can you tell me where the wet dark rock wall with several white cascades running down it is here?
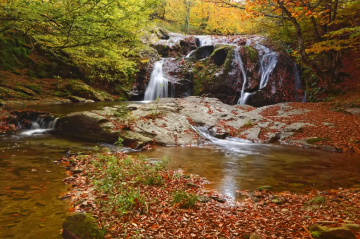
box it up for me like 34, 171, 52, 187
144, 34, 304, 106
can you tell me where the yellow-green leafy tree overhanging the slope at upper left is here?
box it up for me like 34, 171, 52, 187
0, 0, 159, 93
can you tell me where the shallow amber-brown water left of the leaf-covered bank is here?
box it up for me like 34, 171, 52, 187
0, 135, 102, 239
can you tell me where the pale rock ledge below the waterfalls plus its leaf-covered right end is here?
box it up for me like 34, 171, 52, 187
56, 96, 360, 151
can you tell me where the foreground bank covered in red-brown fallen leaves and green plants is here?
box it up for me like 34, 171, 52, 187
65, 152, 360, 238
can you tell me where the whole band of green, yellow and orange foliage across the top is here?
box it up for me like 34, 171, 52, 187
0, 0, 360, 95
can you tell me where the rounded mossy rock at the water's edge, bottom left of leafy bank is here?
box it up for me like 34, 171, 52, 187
63, 213, 105, 239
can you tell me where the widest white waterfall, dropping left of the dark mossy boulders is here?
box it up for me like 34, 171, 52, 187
144, 59, 168, 101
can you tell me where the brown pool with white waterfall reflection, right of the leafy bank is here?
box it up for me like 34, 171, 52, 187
136, 144, 360, 197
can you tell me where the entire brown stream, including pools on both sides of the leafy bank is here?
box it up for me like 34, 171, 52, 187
0, 102, 360, 238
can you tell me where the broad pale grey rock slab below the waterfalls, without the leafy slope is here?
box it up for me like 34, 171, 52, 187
56, 96, 352, 152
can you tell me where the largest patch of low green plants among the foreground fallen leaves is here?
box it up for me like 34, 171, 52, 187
92, 153, 167, 215
